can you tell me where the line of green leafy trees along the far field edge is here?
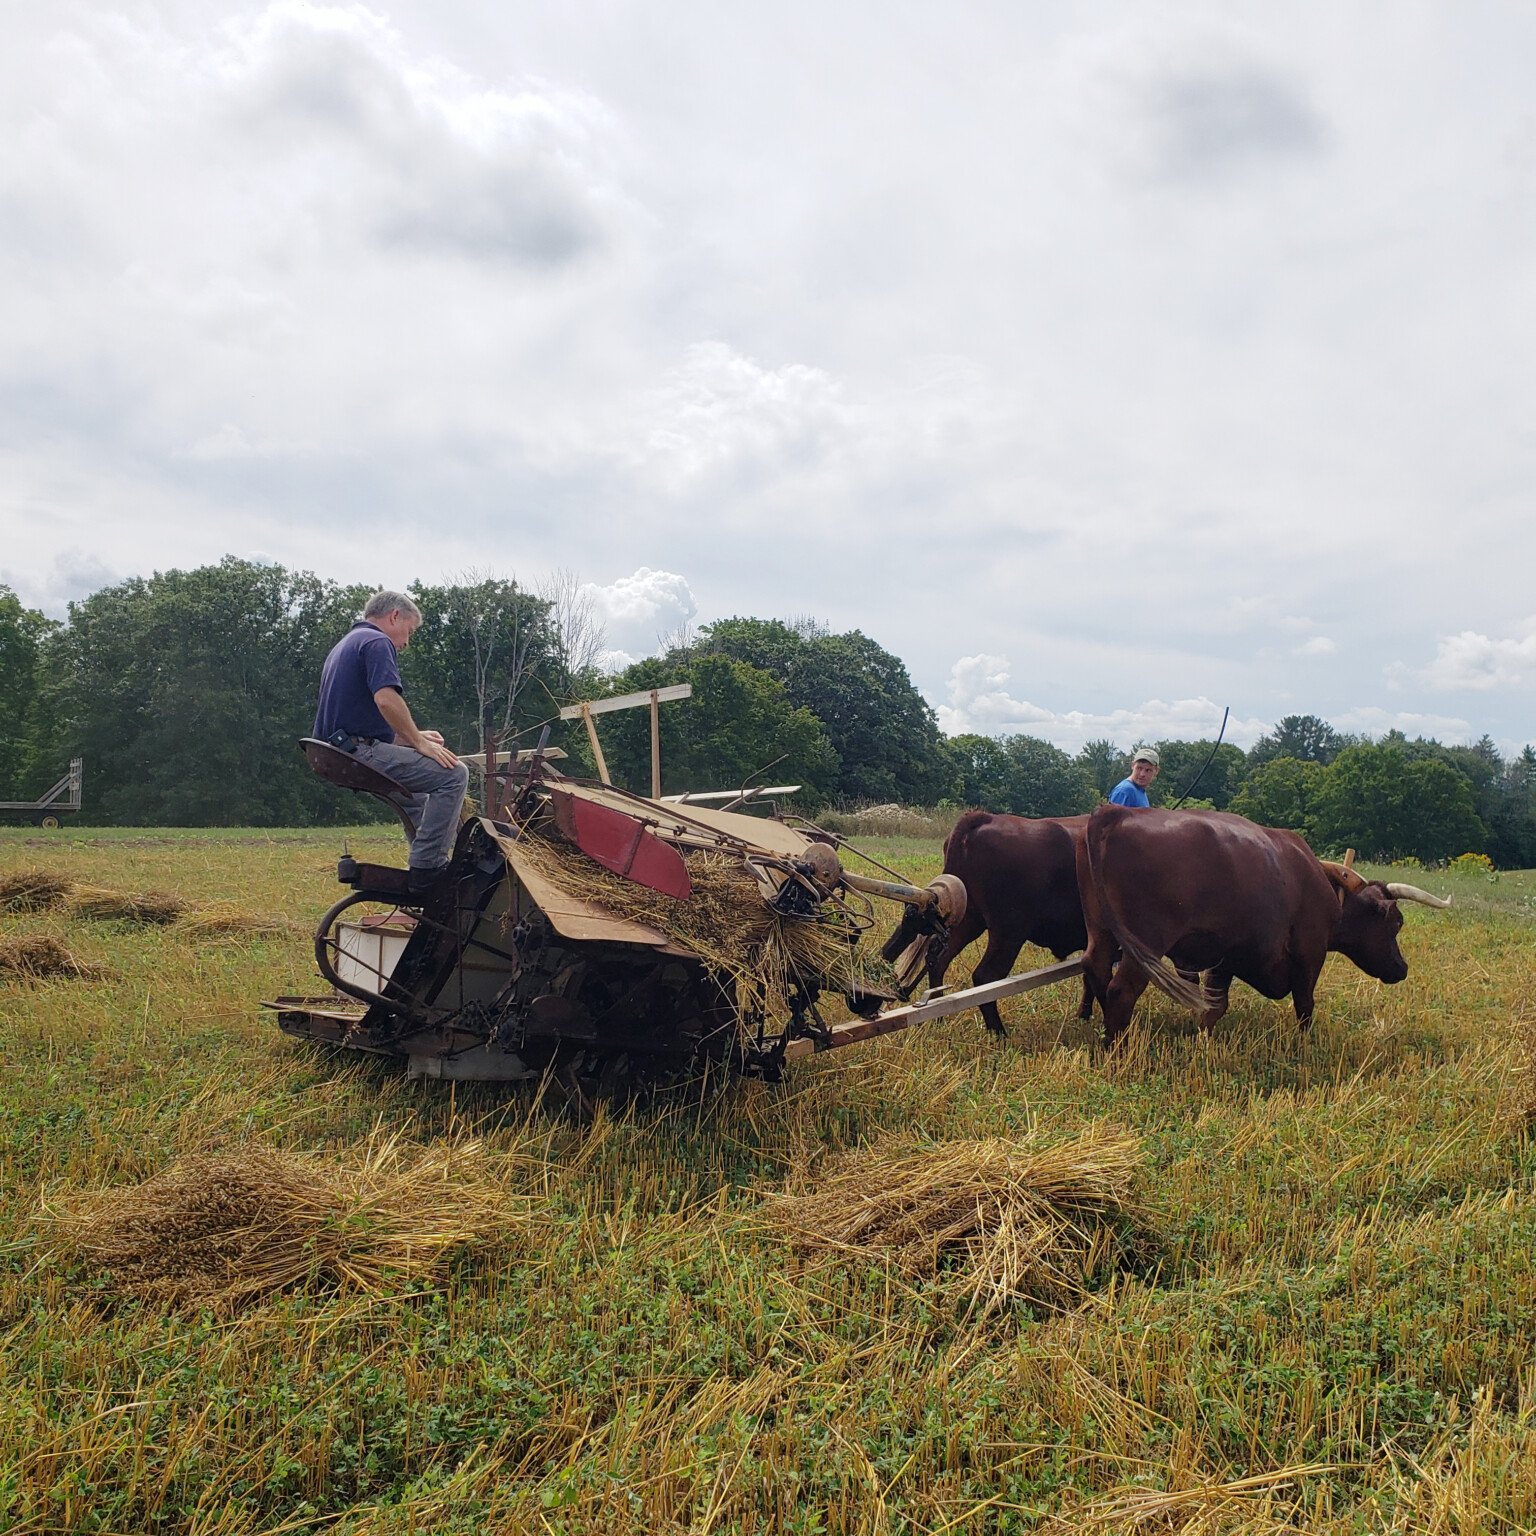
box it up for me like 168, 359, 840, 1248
0, 558, 1536, 868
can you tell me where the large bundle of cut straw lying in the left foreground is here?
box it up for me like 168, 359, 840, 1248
41, 1137, 508, 1312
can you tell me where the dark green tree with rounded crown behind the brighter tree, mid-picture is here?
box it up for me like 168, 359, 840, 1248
699, 619, 955, 805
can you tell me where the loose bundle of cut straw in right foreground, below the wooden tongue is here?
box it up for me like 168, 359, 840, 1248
766, 1126, 1144, 1316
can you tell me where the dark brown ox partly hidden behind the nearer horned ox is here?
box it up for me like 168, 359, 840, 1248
880, 811, 1094, 1035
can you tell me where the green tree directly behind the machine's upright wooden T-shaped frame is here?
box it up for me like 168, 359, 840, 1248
598, 656, 837, 811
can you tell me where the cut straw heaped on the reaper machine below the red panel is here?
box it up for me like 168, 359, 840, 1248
518, 837, 871, 1021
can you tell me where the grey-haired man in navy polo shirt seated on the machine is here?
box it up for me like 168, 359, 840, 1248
313, 591, 470, 894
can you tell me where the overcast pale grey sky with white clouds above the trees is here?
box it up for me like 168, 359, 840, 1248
0, 0, 1536, 751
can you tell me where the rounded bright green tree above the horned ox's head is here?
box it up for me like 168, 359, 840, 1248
1316, 740, 1487, 863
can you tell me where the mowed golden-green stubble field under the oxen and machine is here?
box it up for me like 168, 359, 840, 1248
0, 828, 1536, 1536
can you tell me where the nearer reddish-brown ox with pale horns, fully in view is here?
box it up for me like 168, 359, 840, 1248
1078, 805, 1450, 1046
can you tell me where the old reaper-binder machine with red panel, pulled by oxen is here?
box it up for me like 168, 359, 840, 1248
267, 728, 1080, 1098
